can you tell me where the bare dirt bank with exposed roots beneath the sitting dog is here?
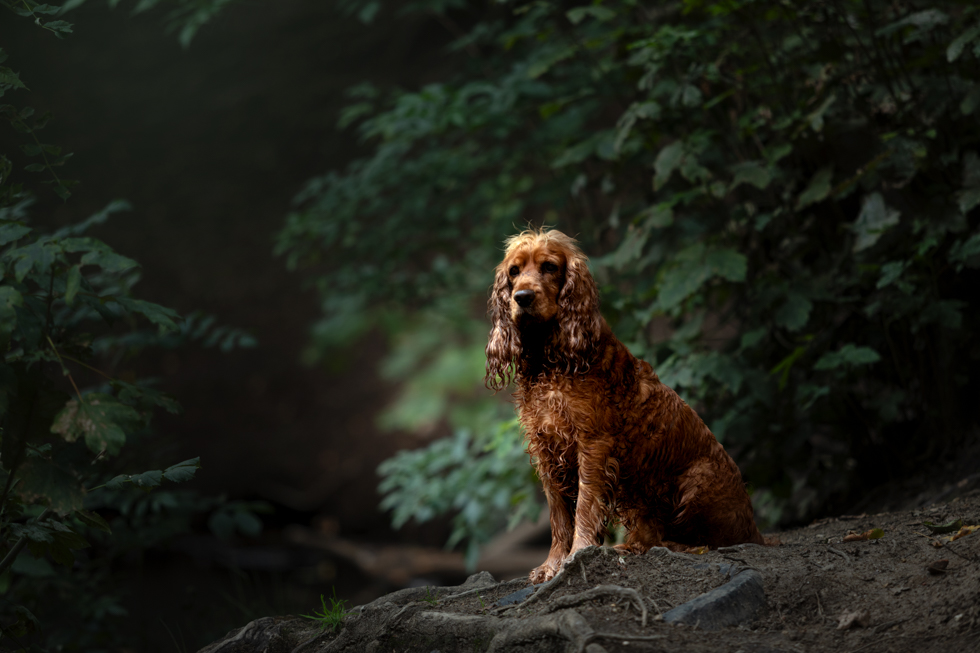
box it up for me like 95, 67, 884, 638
202, 488, 980, 653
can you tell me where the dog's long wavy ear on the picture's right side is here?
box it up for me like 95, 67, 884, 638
557, 251, 602, 372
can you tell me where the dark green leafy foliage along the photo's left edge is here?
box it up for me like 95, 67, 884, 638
0, 1, 256, 651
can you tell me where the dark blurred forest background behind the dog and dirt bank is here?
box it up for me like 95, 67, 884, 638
0, 0, 980, 651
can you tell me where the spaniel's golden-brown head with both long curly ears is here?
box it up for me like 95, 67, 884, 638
486, 229, 601, 390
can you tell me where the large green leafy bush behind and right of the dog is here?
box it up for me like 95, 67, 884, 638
279, 0, 980, 552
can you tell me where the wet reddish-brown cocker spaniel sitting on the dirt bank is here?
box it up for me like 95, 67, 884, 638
486, 230, 763, 583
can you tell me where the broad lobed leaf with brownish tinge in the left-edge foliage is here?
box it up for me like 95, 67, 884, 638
51, 392, 140, 455
